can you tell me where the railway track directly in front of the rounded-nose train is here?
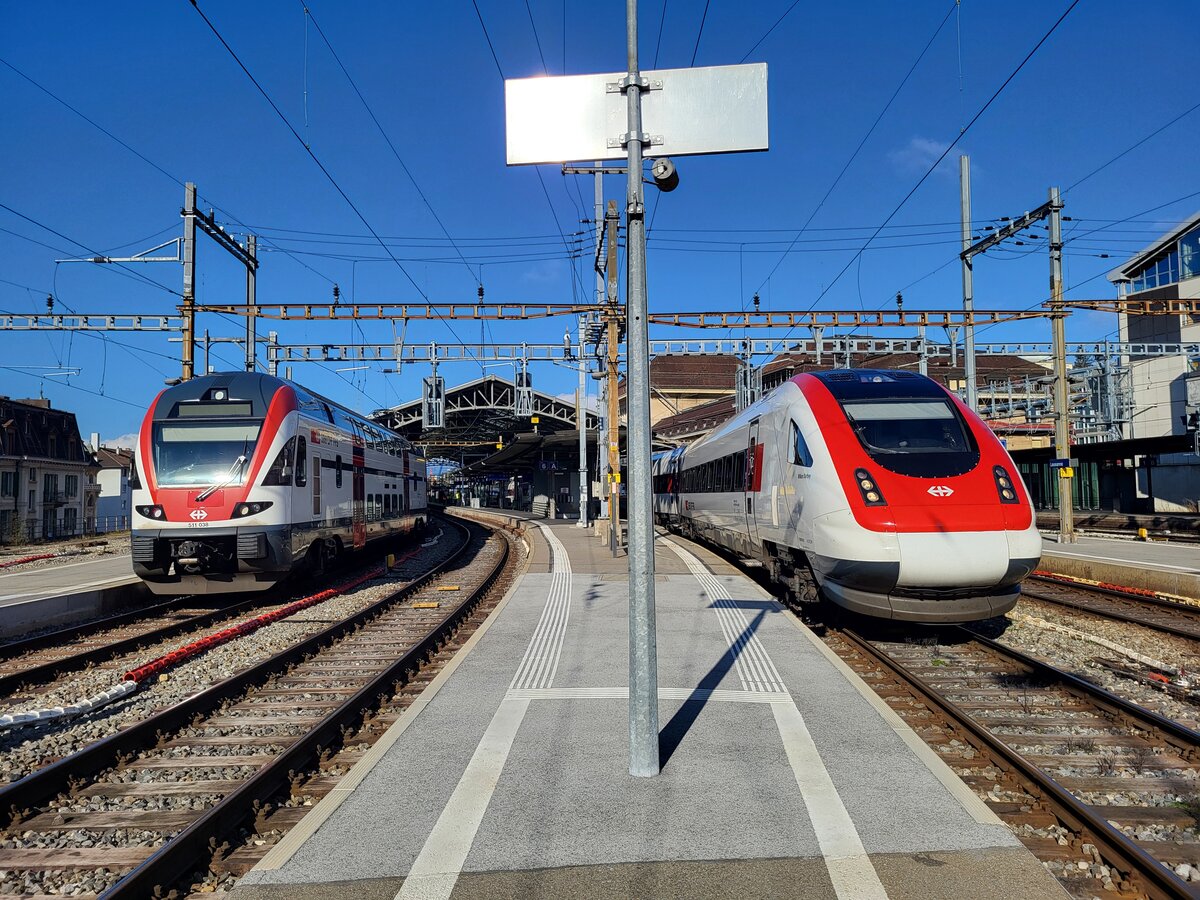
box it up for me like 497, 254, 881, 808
826, 629, 1200, 898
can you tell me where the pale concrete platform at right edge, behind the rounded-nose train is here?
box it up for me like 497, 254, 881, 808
1040, 536, 1200, 599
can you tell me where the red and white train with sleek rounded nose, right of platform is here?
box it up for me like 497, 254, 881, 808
654, 370, 1042, 623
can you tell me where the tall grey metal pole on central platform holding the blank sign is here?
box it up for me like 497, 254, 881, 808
625, 0, 660, 776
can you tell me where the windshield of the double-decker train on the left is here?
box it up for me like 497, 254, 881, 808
154, 420, 262, 487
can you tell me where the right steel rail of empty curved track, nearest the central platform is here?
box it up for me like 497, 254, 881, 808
102, 526, 509, 900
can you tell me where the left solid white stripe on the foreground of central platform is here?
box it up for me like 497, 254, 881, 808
396, 698, 529, 900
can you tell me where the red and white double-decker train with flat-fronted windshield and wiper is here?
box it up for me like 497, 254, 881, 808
132, 372, 427, 594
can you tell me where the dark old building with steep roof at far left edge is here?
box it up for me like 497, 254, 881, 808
0, 397, 100, 544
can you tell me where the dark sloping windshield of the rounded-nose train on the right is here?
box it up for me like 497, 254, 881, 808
842, 400, 979, 478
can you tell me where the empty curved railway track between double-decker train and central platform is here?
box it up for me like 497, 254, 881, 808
0, 513, 511, 898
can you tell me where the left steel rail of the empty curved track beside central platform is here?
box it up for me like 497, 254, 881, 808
0, 520, 470, 822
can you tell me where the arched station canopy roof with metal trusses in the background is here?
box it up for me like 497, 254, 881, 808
372, 376, 599, 466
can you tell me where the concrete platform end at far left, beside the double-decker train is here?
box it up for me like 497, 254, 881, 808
0, 553, 150, 637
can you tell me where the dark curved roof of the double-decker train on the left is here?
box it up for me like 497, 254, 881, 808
154, 372, 409, 445
